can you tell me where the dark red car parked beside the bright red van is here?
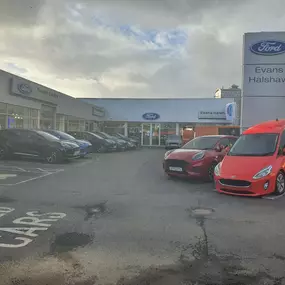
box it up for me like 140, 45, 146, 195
163, 135, 237, 181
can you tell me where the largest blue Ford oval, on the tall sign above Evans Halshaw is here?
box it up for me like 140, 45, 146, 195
250, 41, 285, 55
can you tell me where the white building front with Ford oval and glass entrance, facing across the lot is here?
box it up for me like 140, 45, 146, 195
80, 98, 236, 146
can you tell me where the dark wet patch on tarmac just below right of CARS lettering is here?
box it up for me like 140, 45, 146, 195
50, 232, 93, 253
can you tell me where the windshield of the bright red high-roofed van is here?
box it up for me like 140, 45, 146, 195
228, 134, 279, 156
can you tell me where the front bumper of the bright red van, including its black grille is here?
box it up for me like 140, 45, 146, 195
215, 175, 276, 197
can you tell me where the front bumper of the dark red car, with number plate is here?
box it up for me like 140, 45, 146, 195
163, 159, 209, 178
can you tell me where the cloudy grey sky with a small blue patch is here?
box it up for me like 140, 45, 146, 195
0, 0, 285, 98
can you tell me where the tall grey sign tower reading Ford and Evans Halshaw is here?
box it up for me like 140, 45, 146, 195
241, 32, 285, 129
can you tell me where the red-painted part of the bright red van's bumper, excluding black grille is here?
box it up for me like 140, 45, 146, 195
215, 175, 276, 197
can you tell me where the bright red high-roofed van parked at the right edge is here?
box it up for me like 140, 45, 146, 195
215, 120, 285, 196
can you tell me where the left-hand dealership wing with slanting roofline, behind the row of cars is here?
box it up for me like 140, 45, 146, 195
0, 70, 105, 131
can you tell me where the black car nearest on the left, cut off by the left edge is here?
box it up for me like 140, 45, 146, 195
0, 129, 80, 163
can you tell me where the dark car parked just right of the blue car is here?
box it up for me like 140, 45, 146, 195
68, 131, 117, 152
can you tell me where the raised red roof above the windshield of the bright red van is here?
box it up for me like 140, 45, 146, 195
243, 119, 285, 135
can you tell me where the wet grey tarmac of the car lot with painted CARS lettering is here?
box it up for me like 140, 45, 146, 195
0, 149, 285, 285
